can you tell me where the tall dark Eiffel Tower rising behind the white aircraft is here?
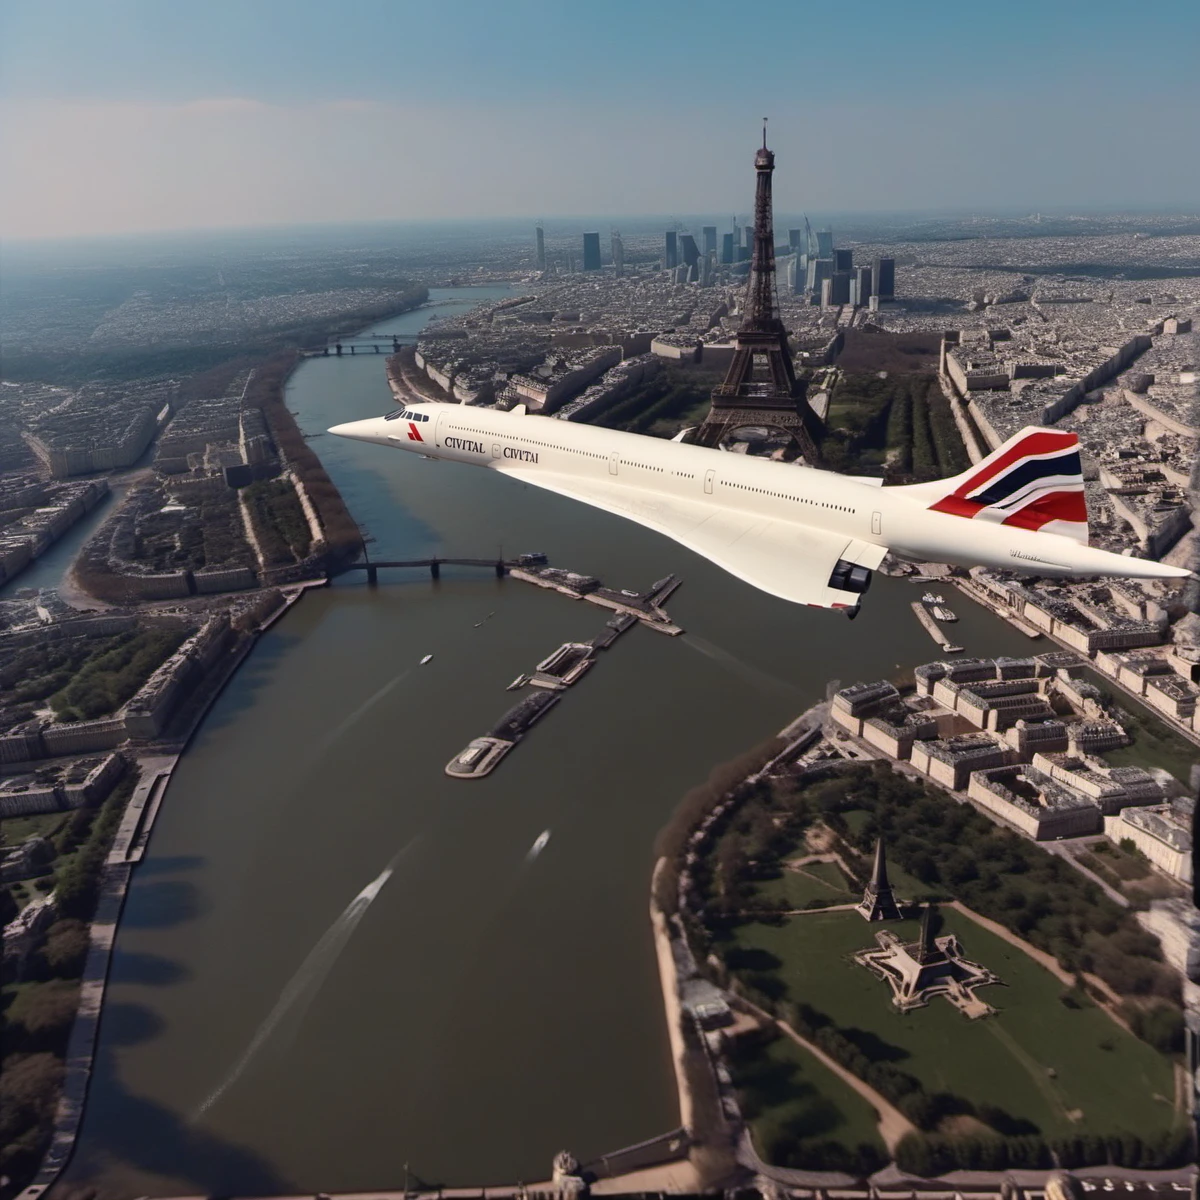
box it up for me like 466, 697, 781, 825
695, 118, 817, 462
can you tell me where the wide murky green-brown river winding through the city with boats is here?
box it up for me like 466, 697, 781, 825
68, 288, 1030, 1196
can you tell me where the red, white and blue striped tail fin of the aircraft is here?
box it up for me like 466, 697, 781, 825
900, 425, 1087, 545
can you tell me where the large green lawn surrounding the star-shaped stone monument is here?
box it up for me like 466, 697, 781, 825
733, 902, 1176, 1136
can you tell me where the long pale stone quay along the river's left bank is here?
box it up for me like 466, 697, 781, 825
18, 580, 328, 1200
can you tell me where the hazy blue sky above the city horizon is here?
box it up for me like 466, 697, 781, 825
0, 0, 1200, 238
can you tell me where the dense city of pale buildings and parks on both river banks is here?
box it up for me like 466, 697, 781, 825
0, 119, 1200, 1196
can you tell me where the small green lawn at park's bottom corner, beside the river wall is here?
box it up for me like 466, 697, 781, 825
731, 1037, 887, 1157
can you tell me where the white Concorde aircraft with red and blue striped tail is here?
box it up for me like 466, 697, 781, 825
329, 402, 1190, 617
